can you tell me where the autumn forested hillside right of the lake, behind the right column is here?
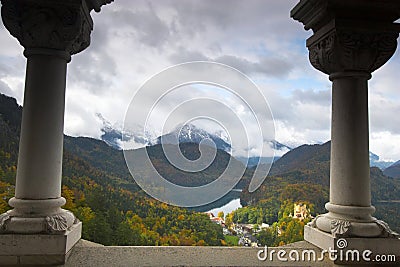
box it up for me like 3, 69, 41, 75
241, 142, 400, 231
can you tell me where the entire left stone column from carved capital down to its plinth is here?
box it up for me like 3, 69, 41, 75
0, 0, 109, 264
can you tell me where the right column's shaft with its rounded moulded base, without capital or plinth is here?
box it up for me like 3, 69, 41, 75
314, 71, 383, 237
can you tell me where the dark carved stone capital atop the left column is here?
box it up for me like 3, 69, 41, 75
1, 0, 93, 54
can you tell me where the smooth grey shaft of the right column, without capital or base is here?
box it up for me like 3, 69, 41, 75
330, 72, 371, 207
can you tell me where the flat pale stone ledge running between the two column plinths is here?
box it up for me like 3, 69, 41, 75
64, 241, 334, 267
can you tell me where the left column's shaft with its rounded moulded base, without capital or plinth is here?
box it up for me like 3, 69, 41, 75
4, 49, 75, 233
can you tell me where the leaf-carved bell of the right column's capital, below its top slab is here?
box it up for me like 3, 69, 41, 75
308, 28, 398, 74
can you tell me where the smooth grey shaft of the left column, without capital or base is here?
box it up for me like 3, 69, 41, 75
15, 54, 67, 199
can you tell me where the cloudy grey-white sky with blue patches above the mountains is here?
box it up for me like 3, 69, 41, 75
0, 0, 400, 160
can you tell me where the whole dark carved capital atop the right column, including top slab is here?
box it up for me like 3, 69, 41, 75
290, 0, 400, 74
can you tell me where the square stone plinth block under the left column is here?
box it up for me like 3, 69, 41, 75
0, 222, 82, 265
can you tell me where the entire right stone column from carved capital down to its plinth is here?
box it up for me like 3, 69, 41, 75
291, 0, 400, 262
